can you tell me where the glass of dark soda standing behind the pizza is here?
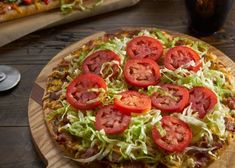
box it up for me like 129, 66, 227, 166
185, 0, 233, 36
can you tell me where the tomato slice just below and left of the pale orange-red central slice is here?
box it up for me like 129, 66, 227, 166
95, 105, 131, 134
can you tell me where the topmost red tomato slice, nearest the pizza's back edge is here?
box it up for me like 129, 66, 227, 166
126, 36, 163, 61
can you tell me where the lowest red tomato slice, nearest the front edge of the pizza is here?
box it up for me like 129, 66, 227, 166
152, 116, 192, 153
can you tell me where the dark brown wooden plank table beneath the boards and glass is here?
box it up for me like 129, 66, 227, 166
0, 0, 235, 168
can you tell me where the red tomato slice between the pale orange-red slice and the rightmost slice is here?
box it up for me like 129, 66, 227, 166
151, 84, 189, 112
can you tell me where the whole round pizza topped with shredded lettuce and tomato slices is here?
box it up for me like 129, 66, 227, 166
43, 29, 235, 168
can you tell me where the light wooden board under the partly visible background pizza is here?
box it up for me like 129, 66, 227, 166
0, 0, 140, 47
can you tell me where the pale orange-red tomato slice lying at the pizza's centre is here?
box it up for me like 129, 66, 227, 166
114, 91, 151, 114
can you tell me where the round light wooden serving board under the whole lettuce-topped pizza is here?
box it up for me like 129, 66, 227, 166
28, 28, 235, 168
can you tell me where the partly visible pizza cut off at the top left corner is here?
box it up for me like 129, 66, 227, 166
0, 0, 102, 23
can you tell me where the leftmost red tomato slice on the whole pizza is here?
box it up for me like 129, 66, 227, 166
66, 74, 106, 110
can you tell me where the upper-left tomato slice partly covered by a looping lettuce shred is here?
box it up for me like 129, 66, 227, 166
82, 50, 120, 75
